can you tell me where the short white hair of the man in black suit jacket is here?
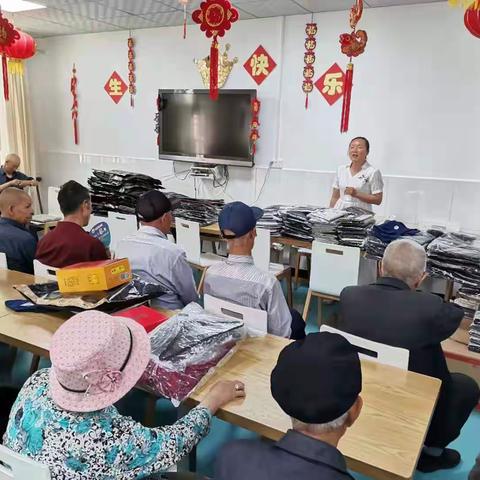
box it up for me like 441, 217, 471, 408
382, 239, 427, 288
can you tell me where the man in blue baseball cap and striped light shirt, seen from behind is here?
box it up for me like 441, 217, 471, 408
204, 202, 305, 340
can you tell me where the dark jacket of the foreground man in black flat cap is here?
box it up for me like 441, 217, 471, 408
215, 430, 353, 480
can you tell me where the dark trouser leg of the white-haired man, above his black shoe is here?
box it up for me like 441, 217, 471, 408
425, 373, 480, 448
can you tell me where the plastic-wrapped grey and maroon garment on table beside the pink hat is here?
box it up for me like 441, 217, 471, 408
140, 303, 246, 404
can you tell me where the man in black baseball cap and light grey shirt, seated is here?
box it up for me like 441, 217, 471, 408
115, 190, 198, 310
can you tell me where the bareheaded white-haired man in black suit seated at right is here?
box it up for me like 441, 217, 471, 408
339, 240, 480, 472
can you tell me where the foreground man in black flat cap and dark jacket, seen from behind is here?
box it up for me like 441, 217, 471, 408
215, 332, 362, 480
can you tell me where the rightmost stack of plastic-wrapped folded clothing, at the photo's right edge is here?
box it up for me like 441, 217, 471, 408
427, 233, 480, 291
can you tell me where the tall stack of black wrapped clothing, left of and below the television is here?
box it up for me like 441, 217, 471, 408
88, 170, 163, 216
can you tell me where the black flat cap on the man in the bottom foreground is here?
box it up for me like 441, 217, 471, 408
270, 332, 362, 424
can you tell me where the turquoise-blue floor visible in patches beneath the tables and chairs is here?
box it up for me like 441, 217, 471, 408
0, 287, 480, 480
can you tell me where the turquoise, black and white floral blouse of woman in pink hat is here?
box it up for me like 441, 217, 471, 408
3, 369, 211, 480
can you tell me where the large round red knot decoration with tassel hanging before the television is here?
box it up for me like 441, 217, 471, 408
192, 0, 238, 100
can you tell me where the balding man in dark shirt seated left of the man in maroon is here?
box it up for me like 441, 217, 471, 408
0, 187, 37, 273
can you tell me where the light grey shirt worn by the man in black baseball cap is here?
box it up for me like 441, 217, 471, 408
115, 226, 198, 310
